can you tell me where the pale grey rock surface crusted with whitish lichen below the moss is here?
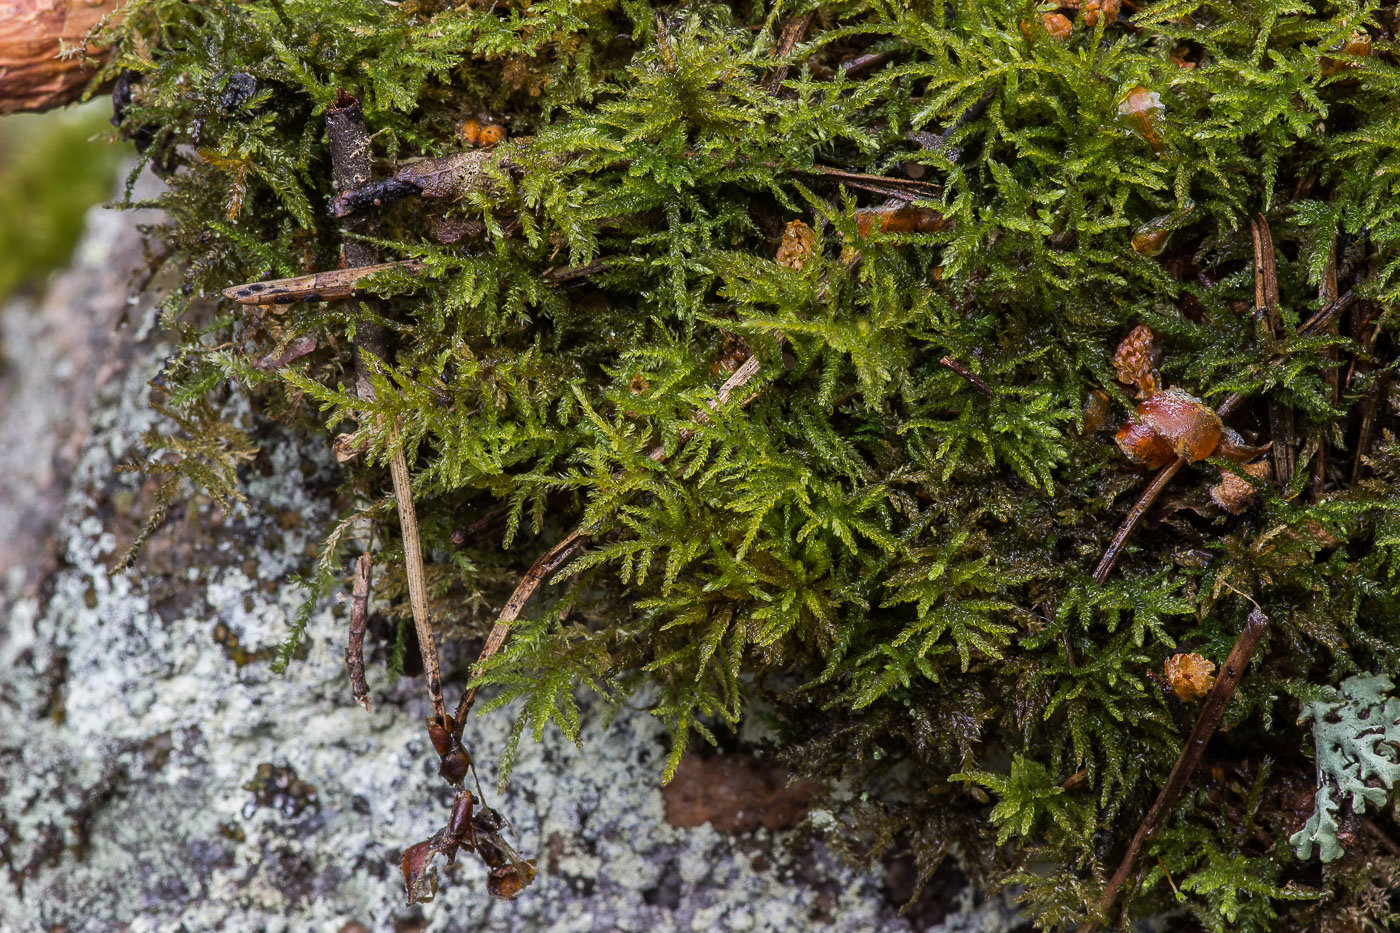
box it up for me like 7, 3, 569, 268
0, 182, 1030, 933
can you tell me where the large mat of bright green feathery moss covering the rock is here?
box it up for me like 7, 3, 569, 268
93, 0, 1400, 930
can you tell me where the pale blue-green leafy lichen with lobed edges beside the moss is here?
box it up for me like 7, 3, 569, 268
1289, 674, 1400, 862
